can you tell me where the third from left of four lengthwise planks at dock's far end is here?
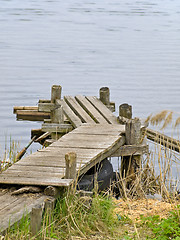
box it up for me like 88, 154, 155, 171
75, 95, 108, 124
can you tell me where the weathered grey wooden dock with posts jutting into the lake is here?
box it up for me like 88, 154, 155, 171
0, 86, 148, 234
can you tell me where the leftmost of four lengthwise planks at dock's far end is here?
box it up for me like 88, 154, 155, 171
56, 100, 82, 128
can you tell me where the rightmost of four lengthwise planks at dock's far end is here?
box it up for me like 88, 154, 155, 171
86, 96, 117, 124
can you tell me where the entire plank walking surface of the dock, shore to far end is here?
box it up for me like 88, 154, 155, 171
0, 93, 125, 232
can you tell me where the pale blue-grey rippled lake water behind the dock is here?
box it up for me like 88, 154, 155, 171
0, 0, 180, 159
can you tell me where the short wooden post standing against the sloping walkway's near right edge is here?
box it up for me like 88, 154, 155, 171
65, 152, 77, 179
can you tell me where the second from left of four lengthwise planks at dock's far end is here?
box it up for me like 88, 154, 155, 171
64, 96, 95, 123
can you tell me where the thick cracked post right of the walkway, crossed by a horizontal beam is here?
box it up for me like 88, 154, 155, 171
121, 118, 141, 180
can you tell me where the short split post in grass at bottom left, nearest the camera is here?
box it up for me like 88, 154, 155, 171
30, 204, 42, 237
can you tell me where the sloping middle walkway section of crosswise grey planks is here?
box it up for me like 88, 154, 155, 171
0, 124, 125, 186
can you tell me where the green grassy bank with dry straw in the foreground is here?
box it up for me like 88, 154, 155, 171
2, 189, 180, 240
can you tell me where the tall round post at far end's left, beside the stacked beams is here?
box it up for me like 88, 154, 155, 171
51, 85, 64, 140
